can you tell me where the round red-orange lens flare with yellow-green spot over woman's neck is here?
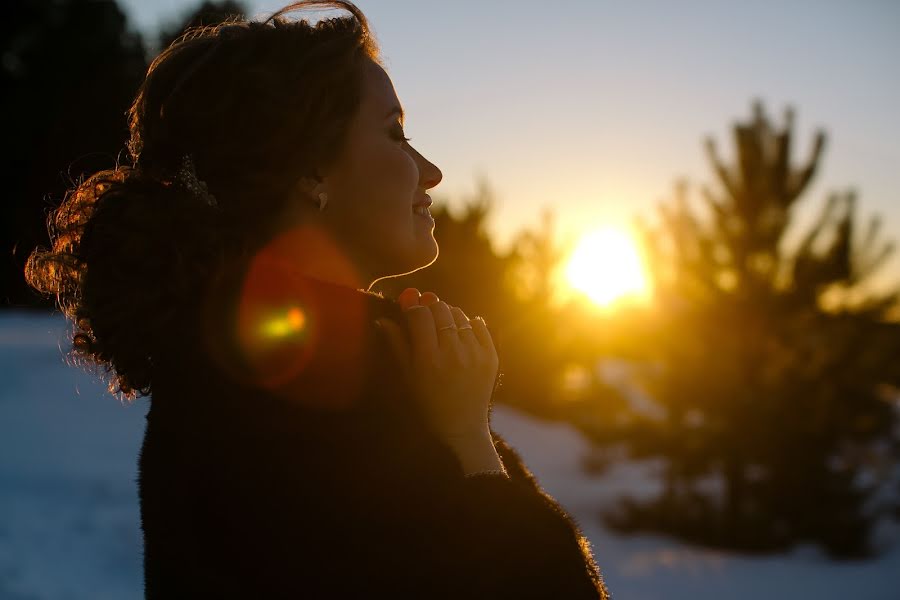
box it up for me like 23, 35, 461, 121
233, 226, 370, 408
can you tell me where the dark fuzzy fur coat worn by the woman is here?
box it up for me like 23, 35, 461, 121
138, 280, 609, 599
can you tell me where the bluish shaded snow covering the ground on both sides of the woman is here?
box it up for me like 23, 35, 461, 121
0, 311, 900, 600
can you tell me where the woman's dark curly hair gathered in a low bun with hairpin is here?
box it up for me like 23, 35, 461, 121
25, 0, 381, 400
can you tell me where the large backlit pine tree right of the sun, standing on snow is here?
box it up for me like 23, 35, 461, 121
607, 103, 900, 556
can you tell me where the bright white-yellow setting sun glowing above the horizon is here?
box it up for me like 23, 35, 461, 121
565, 228, 647, 306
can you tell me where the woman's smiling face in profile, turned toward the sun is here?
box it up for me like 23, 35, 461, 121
323, 60, 442, 278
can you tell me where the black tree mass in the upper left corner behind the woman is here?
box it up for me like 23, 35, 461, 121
0, 0, 147, 307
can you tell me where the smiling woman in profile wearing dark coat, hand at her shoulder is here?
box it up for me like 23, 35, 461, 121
27, 1, 608, 598
